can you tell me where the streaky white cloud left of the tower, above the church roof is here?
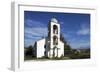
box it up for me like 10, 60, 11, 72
24, 27, 47, 46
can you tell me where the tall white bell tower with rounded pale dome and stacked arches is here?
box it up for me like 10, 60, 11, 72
48, 18, 60, 58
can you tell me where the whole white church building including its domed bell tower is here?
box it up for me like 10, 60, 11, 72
34, 18, 64, 58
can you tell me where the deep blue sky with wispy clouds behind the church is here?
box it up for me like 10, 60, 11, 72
24, 11, 90, 49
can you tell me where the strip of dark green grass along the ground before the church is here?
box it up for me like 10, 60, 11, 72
24, 53, 90, 61
